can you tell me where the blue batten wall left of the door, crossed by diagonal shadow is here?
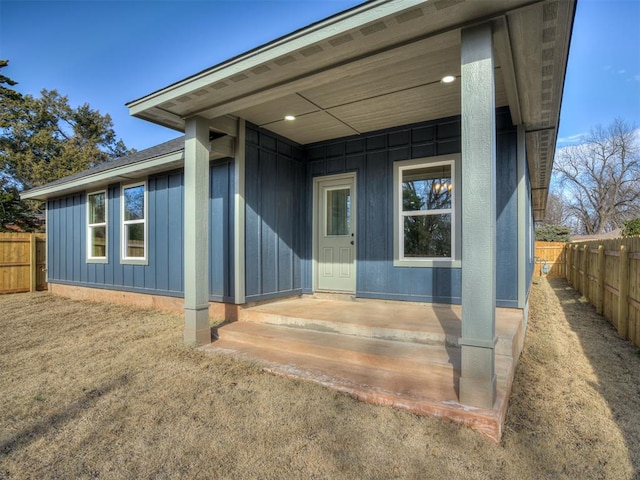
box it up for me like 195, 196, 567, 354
245, 123, 306, 301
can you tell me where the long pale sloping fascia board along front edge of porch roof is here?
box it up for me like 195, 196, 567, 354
126, 0, 426, 116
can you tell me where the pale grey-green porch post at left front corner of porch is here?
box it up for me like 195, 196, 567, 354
184, 117, 211, 346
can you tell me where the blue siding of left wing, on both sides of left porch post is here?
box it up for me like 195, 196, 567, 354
47, 161, 233, 301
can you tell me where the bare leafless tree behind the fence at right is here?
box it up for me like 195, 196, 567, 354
554, 119, 640, 235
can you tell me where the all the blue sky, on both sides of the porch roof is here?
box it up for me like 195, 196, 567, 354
0, 0, 640, 150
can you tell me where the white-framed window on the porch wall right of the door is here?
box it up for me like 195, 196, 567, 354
394, 156, 460, 266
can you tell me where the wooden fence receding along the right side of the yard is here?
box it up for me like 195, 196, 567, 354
566, 237, 640, 347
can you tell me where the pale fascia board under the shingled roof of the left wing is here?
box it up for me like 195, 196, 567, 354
20, 151, 184, 200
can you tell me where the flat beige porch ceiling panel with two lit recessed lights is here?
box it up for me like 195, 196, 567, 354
230, 32, 507, 144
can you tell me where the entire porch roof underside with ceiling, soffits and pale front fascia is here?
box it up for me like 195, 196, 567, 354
128, 0, 575, 217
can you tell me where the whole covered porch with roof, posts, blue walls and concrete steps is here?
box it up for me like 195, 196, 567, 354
128, 0, 575, 439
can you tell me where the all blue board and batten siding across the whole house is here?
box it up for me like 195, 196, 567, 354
48, 109, 533, 306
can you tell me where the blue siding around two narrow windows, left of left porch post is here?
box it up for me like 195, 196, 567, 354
47, 172, 183, 296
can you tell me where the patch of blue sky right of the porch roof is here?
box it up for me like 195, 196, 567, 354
558, 0, 640, 146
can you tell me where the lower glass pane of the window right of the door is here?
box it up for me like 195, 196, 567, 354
404, 215, 451, 258
